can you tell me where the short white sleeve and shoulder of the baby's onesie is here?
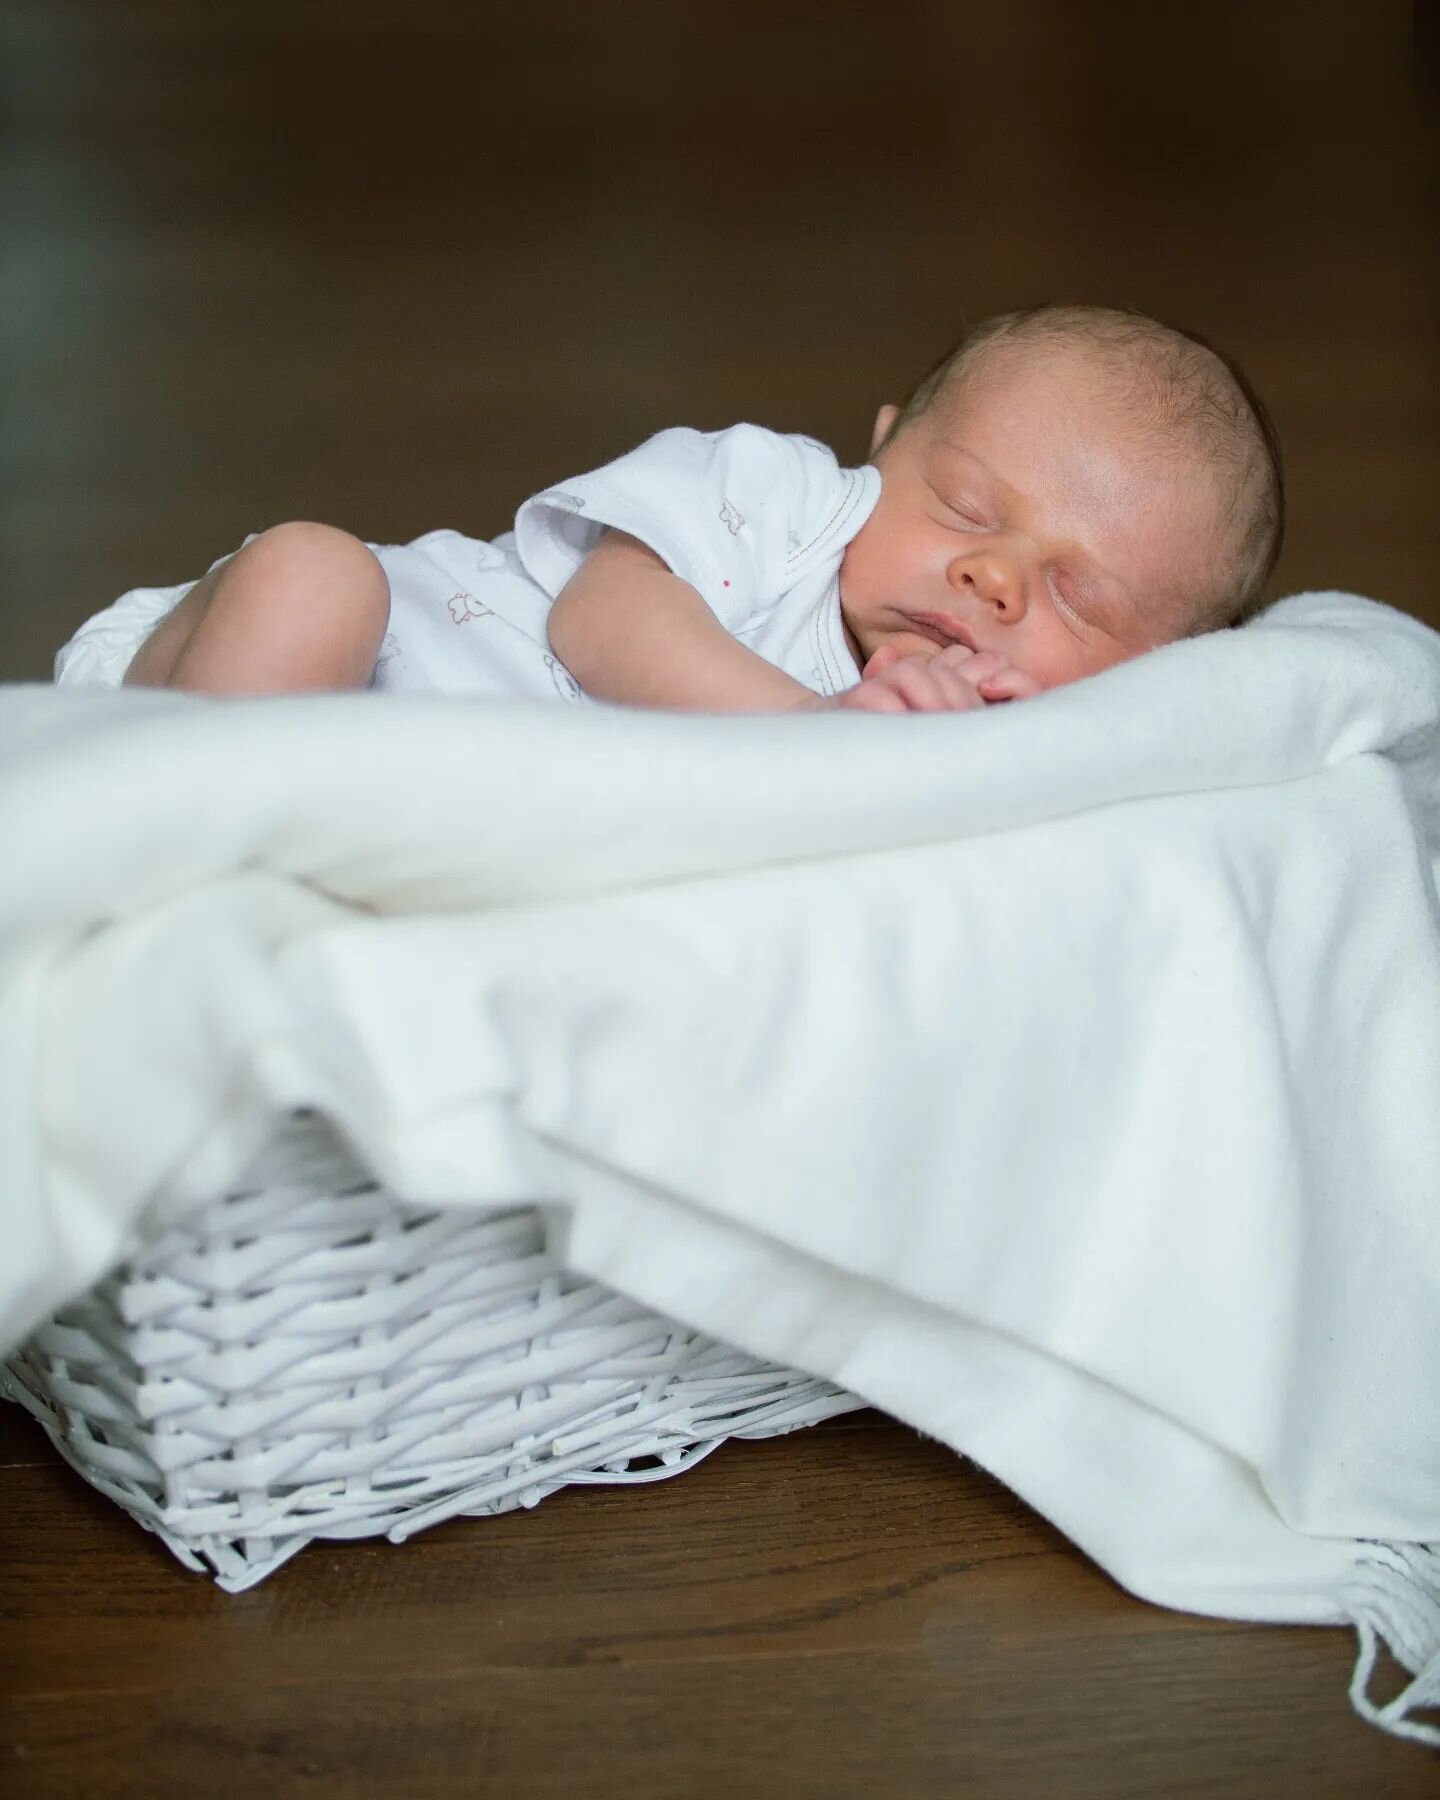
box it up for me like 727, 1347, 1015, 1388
515, 425, 878, 632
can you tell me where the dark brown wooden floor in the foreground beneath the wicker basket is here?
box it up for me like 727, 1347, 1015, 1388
0, 1409, 1440, 1800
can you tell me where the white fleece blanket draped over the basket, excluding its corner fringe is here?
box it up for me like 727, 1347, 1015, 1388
0, 594, 1440, 1728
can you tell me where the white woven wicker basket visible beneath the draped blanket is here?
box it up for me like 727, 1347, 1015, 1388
0, 1118, 860, 1593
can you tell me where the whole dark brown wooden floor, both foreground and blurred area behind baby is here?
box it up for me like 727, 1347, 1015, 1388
0, 0, 1440, 1800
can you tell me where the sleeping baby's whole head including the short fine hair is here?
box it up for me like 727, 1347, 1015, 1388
841, 306, 1285, 688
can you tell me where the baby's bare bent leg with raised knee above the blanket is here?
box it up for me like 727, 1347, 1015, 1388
124, 524, 391, 693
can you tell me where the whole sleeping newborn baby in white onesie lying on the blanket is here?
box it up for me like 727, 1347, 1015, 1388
56, 306, 1283, 713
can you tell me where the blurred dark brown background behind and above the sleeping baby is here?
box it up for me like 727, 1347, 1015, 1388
0, 0, 1440, 679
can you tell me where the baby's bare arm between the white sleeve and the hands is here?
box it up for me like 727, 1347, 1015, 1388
549, 529, 819, 713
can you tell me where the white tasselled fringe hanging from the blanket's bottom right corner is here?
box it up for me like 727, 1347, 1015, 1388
1341, 1543, 1440, 1748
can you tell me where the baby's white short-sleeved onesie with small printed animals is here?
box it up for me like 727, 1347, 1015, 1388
56, 425, 880, 702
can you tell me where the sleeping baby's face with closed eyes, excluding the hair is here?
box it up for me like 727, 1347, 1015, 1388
841, 346, 1222, 688
